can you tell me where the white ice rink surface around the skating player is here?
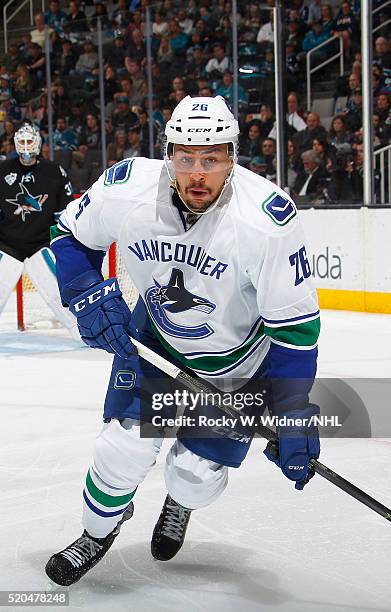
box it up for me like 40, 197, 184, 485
0, 311, 391, 612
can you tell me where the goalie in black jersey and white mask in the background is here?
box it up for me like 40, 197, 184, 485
0, 122, 78, 338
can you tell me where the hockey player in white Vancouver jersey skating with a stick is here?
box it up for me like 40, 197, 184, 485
46, 96, 319, 585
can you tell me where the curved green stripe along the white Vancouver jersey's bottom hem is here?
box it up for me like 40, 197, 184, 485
150, 319, 265, 373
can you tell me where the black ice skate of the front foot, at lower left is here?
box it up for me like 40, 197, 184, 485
45, 502, 133, 586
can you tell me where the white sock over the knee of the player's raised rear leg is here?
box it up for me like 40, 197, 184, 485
164, 440, 228, 510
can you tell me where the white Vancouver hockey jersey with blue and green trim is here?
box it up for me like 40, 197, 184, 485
59, 158, 319, 380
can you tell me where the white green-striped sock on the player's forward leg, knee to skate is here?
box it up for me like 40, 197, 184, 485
83, 419, 163, 538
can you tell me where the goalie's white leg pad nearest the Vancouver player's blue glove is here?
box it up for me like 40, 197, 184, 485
25, 248, 79, 338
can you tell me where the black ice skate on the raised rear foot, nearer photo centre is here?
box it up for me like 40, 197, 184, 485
151, 495, 192, 561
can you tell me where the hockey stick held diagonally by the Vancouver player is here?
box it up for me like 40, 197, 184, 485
131, 338, 391, 521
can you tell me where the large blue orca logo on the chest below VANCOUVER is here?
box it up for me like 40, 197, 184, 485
145, 268, 216, 339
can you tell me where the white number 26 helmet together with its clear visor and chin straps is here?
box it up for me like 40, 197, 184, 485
164, 96, 239, 213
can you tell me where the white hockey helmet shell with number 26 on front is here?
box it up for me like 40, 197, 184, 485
164, 96, 239, 180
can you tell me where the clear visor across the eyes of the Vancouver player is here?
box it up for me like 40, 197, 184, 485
169, 147, 233, 175
